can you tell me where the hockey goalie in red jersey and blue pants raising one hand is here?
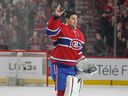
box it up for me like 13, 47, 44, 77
46, 5, 96, 96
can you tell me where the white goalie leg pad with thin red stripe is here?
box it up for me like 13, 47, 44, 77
64, 75, 82, 96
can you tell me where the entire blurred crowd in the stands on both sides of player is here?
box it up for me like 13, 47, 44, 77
0, 0, 128, 57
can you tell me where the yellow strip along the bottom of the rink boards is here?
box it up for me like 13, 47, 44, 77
0, 78, 128, 86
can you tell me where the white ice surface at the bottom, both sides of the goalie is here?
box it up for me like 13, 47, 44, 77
0, 86, 128, 96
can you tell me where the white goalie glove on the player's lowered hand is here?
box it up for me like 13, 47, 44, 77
76, 59, 97, 77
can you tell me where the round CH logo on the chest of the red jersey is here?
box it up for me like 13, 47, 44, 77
70, 39, 82, 50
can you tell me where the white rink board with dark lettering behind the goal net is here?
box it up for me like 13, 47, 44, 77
0, 51, 47, 85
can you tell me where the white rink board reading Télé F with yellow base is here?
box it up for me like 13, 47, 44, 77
49, 58, 128, 86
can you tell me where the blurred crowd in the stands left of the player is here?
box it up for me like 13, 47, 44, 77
0, 0, 75, 50
